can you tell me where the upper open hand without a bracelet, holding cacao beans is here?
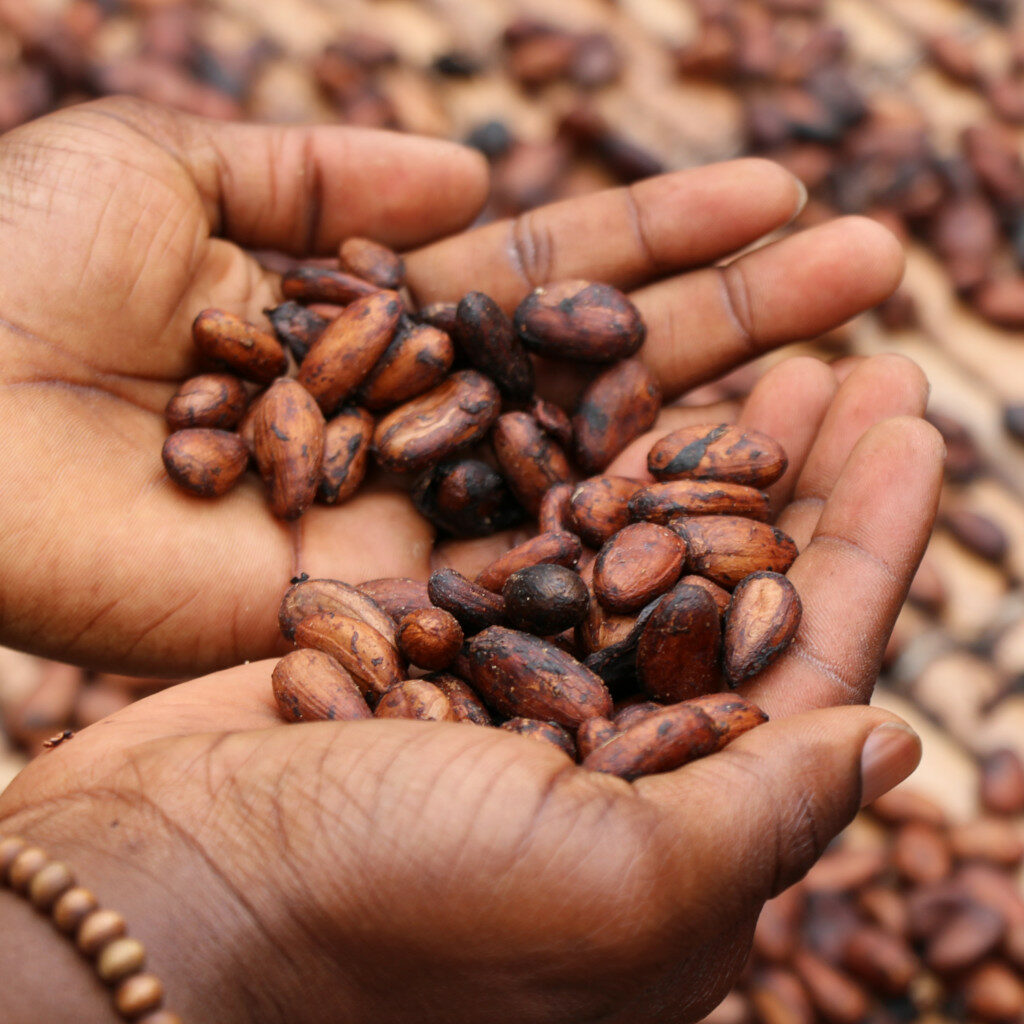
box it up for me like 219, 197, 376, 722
0, 99, 901, 675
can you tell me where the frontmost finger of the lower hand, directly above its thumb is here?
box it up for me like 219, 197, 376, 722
741, 417, 945, 717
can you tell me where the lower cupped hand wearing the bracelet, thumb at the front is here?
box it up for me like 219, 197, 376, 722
0, 356, 943, 1024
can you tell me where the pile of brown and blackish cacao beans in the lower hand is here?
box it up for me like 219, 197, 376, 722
273, 411, 801, 779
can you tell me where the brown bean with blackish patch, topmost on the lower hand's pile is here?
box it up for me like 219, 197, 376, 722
647, 423, 787, 487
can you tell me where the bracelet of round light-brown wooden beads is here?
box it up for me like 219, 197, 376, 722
0, 836, 183, 1024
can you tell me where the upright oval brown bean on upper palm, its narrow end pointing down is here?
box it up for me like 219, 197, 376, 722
253, 377, 325, 519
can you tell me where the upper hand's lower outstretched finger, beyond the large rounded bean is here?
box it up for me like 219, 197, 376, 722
632, 217, 903, 396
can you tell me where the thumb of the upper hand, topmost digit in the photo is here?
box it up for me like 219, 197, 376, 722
82, 98, 487, 255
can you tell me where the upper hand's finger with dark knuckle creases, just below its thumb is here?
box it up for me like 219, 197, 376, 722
407, 160, 806, 309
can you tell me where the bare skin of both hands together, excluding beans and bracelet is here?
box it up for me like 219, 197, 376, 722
0, 100, 942, 1024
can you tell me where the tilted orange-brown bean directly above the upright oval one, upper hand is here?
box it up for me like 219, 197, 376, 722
297, 291, 401, 415
